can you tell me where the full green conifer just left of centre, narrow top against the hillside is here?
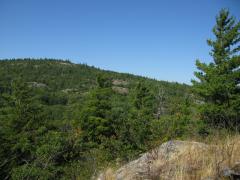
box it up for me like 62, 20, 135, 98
80, 74, 114, 144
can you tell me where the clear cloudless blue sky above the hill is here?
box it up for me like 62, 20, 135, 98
0, 0, 240, 83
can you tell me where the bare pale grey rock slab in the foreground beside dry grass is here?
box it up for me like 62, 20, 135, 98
98, 141, 207, 180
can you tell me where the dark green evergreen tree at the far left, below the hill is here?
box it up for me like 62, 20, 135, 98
1, 81, 43, 178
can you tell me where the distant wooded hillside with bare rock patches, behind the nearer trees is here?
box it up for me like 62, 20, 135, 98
0, 59, 192, 126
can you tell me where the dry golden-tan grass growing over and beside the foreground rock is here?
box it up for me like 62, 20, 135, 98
98, 135, 240, 180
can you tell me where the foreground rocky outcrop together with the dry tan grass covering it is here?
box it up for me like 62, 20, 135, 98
97, 141, 240, 180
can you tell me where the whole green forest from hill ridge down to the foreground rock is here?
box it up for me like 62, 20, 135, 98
0, 59, 196, 179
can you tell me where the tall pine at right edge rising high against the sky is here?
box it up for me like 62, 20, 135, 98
192, 9, 240, 127
